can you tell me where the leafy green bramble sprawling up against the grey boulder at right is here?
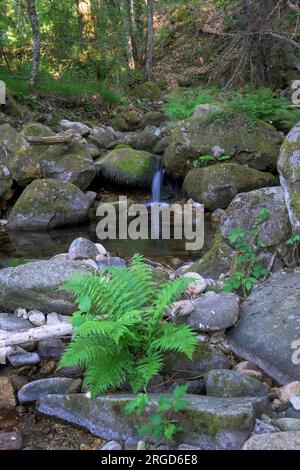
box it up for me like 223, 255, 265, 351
224, 208, 270, 296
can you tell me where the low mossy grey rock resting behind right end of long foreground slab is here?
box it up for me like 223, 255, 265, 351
205, 370, 268, 398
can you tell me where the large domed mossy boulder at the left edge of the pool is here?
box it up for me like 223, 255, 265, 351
7, 179, 89, 230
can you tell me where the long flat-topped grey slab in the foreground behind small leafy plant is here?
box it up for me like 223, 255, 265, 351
37, 394, 269, 450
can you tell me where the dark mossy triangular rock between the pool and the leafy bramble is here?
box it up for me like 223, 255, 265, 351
188, 233, 233, 280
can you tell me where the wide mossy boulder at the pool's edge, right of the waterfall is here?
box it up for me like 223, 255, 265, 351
183, 163, 276, 211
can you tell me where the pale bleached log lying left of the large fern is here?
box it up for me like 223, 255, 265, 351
0, 322, 73, 349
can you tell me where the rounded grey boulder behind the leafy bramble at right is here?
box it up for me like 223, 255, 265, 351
220, 186, 290, 248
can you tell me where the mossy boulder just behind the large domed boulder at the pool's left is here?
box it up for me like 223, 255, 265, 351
39, 142, 97, 190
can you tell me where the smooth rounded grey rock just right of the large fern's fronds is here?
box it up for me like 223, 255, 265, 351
184, 292, 240, 332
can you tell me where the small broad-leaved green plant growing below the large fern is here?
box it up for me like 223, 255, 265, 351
125, 385, 187, 441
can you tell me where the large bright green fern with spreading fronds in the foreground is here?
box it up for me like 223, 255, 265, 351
60, 255, 197, 396
